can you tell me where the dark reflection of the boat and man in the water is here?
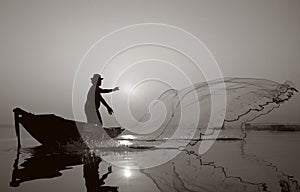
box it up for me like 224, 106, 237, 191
10, 146, 118, 192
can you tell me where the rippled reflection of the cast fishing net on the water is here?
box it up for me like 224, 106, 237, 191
142, 144, 300, 192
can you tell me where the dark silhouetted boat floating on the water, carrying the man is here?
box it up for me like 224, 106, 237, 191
13, 108, 124, 147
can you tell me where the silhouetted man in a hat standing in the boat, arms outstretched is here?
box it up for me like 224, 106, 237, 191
84, 74, 119, 125
